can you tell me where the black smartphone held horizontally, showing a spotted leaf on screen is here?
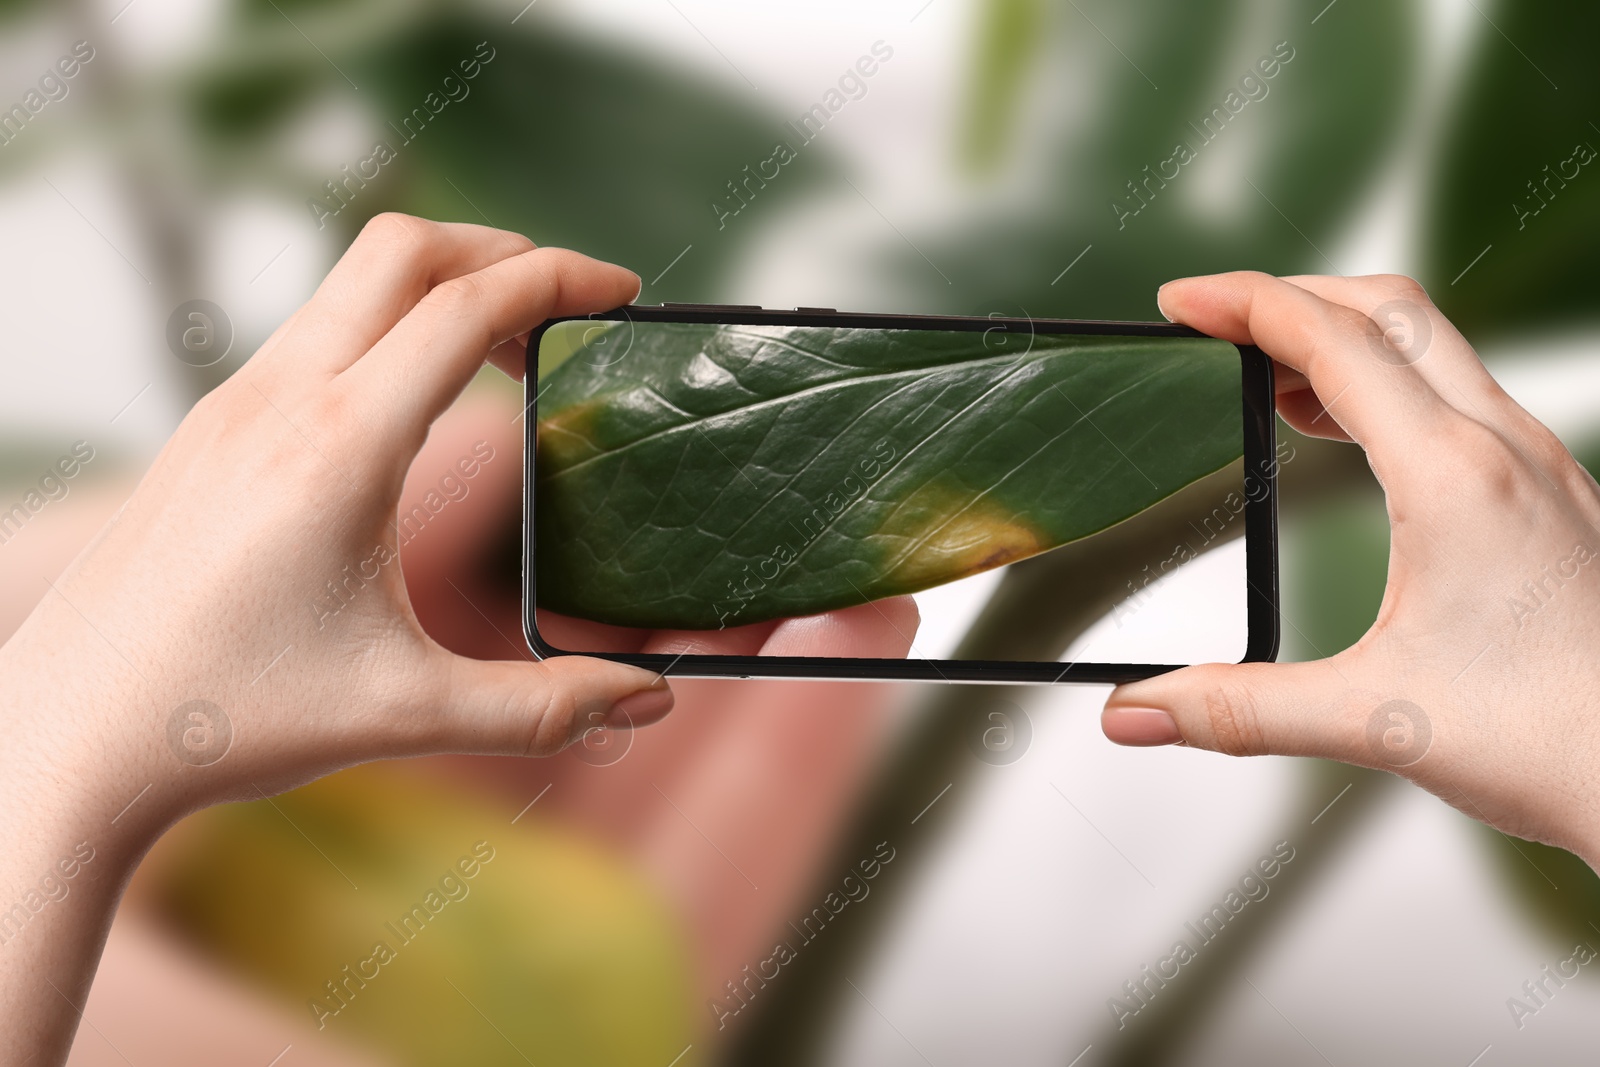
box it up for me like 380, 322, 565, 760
523, 304, 1293, 683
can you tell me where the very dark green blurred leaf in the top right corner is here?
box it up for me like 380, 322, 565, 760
1426, 3, 1600, 336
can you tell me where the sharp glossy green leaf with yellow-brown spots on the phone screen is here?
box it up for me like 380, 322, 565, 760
534, 322, 1242, 629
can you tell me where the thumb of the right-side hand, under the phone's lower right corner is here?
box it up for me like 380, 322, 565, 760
1101, 661, 1358, 760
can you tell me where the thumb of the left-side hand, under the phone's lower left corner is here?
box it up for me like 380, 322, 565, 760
416, 656, 674, 757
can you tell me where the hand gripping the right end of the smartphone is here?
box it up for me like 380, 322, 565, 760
1102, 272, 1600, 869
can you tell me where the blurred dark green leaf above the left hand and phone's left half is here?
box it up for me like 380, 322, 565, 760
329, 14, 827, 299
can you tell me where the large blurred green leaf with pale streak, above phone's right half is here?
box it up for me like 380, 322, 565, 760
885, 0, 1418, 318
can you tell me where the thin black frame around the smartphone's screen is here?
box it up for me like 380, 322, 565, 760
522, 304, 1280, 683
